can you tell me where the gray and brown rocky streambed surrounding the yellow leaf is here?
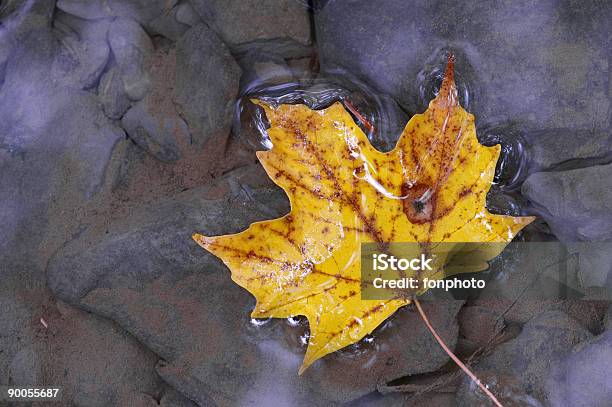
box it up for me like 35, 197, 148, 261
0, 0, 612, 406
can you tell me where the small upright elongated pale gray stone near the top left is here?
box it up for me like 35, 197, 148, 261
108, 18, 153, 100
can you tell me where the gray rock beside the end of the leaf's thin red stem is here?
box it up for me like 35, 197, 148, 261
457, 311, 592, 407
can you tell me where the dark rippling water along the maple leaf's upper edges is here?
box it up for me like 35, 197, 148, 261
233, 52, 529, 216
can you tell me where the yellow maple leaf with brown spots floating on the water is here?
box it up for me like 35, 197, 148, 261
194, 61, 532, 374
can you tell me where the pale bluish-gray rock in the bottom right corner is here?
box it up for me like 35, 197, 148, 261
547, 331, 612, 407
